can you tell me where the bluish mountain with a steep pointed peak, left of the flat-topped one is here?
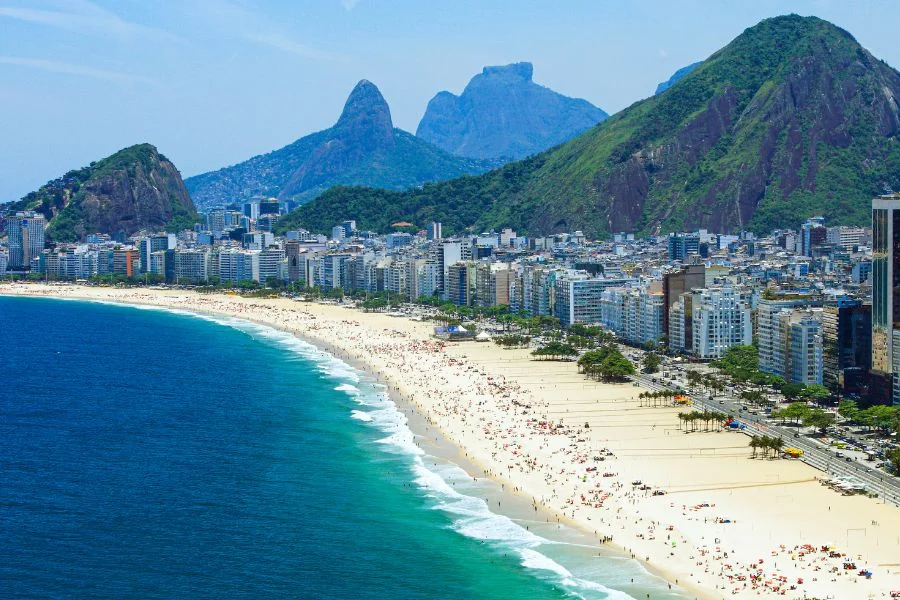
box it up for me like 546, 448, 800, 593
185, 80, 497, 209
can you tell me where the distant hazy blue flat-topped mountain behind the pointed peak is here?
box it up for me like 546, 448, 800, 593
416, 62, 609, 160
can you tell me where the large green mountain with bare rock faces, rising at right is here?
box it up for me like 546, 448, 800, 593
284, 15, 900, 237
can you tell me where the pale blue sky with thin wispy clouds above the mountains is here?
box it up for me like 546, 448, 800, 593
0, 0, 900, 203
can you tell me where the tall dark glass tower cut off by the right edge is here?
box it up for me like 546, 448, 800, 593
872, 194, 900, 404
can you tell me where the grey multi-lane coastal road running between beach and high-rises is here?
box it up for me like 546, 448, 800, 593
632, 374, 900, 506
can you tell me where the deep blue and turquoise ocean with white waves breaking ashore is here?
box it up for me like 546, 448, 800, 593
0, 297, 686, 600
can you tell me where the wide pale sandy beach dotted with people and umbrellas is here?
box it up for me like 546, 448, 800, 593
7, 284, 900, 600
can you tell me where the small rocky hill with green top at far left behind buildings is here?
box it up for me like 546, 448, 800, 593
6, 144, 197, 242
